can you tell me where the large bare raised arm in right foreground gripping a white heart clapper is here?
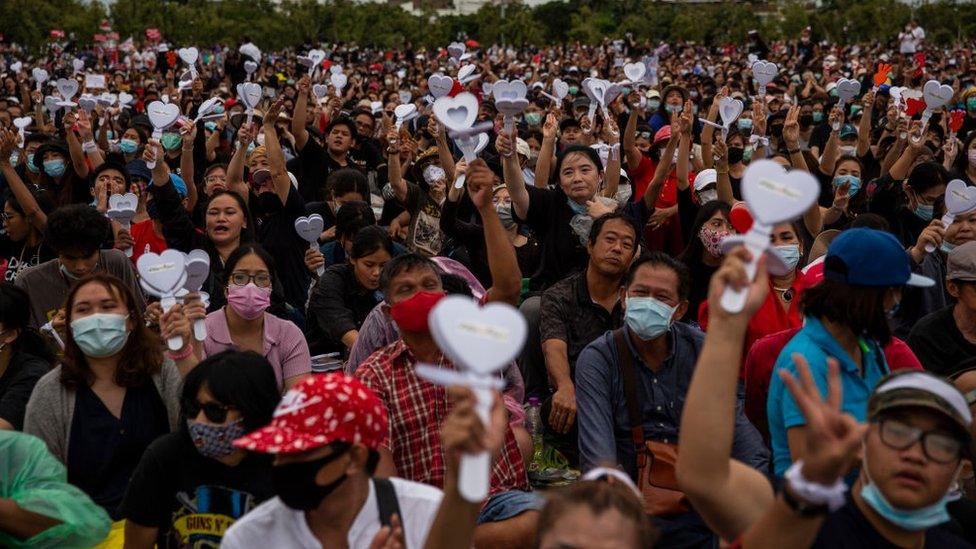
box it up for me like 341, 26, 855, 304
676, 247, 773, 540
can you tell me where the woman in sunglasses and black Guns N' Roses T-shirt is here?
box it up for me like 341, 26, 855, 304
121, 351, 280, 549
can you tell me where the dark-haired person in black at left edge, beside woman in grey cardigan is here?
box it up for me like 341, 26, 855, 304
0, 282, 55, 431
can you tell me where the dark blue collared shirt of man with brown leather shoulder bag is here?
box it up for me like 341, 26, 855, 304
575, 322, 769, 480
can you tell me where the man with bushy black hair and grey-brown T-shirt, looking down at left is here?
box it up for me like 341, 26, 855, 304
16, 204, 146, 328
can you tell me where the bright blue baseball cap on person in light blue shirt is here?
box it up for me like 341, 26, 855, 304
824, 227, 935, 288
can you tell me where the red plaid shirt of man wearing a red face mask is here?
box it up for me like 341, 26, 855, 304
356, 339, 529, 495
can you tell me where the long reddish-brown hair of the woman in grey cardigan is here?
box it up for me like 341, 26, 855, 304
61, 273, 163, 389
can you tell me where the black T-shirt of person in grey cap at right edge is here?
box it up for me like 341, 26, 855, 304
907, 305, 976, 376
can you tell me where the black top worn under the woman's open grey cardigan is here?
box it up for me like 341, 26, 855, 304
68, 381, 169, 520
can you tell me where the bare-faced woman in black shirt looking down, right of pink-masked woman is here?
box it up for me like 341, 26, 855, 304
307, 226, 394, 354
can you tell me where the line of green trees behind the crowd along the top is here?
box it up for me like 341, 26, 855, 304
0, 0, 976, 51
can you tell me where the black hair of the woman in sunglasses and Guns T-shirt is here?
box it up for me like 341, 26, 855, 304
182, 351, 281, 432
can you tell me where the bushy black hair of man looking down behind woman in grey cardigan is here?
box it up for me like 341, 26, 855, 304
44, 204, 112, 256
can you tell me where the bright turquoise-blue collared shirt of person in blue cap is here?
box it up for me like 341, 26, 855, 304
766, 316, 888, 477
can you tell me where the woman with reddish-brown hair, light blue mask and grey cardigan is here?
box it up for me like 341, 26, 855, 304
24, 274, 182, 520
